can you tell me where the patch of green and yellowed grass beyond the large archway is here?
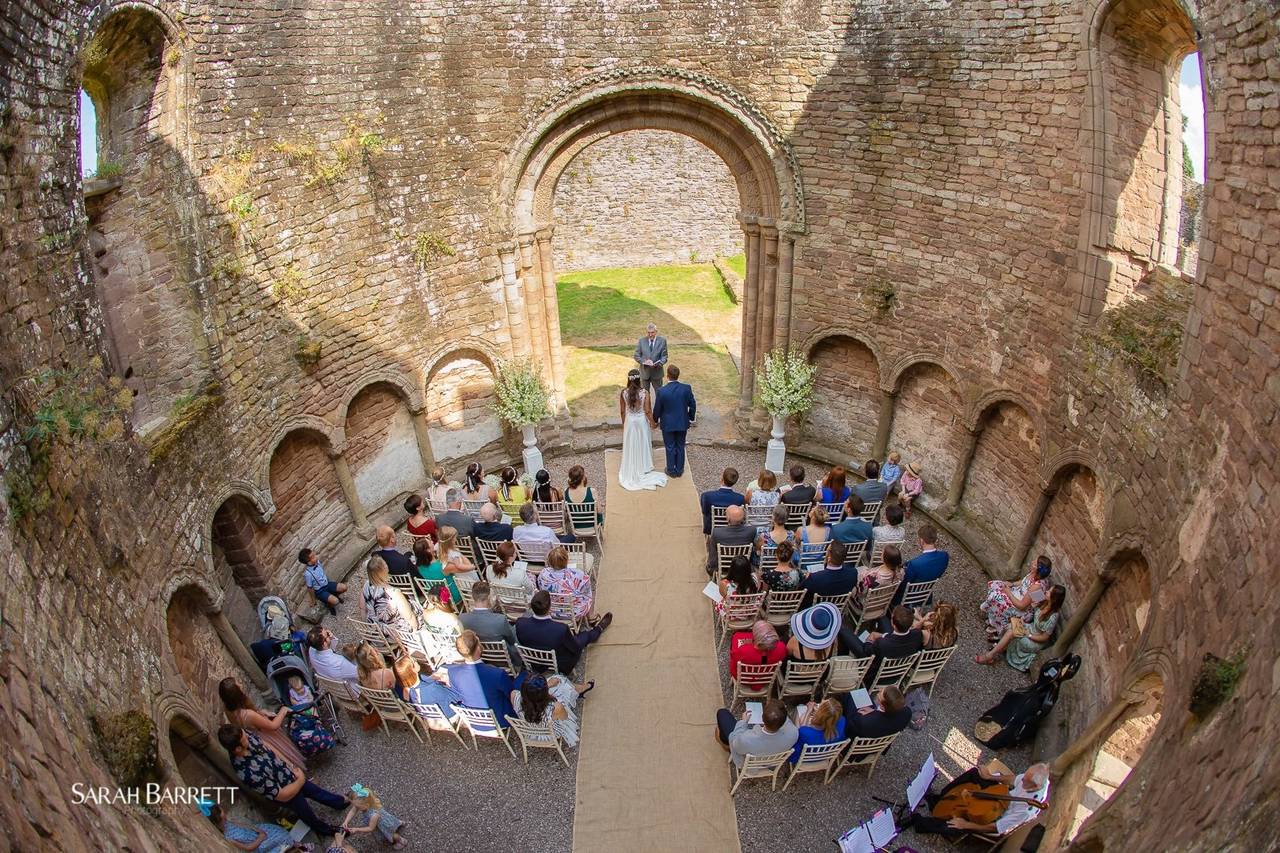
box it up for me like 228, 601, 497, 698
556, 258, 742, 420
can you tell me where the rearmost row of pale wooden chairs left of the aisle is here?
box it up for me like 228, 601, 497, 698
316, 676, 568, 767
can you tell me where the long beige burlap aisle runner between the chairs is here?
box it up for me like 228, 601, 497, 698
573, 450, 741, 853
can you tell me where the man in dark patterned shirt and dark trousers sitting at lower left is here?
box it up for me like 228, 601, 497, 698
218, 724, 351, 835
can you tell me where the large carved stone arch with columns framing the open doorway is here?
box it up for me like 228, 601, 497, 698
495, 68, 804, 409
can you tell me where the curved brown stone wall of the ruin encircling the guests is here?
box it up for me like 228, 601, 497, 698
0, 0, 1280, 850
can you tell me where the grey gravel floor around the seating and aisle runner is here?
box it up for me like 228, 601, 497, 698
294, 447, 1029, 853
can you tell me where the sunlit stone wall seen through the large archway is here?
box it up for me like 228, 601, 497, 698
556, 131, 742, 270
